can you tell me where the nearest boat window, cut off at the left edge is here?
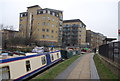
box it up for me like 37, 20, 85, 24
0, 66, 10, 81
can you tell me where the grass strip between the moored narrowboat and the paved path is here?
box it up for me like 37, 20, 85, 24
36, 55, 80, 79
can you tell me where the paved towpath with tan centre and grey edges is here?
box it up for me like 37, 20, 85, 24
56, 53, 99, 79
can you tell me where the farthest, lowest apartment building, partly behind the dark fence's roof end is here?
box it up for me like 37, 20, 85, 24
86, 30, 106, 49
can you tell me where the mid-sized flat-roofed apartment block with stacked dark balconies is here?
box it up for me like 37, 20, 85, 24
63, 19, 86, 47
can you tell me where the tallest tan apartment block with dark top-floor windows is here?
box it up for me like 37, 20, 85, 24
19, 5, 63, 46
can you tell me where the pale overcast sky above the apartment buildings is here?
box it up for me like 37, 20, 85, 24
0, 0, 119, 38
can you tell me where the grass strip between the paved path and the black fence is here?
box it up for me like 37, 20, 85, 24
94, 54, 118, 79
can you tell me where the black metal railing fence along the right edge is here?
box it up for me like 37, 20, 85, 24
99, 41, 120, 64
